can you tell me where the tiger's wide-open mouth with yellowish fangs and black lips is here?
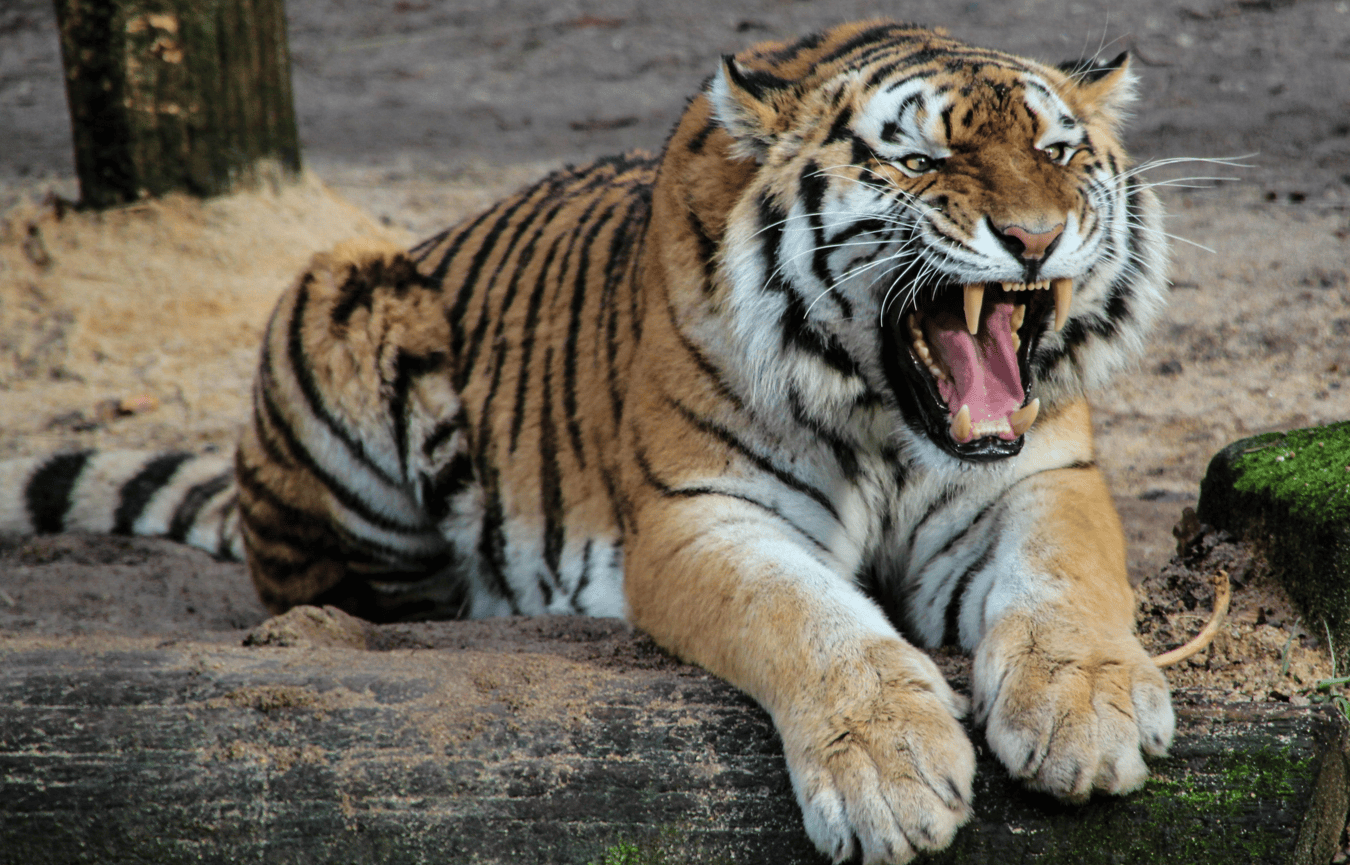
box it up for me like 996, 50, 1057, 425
884, 279, 1073, 462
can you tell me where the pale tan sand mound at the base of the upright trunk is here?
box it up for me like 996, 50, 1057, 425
0, 174, 409, 456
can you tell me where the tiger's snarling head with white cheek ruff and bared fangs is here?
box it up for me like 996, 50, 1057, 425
657, 22, 1166, 462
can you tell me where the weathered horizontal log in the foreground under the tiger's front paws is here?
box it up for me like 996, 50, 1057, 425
0, 607, 1347, 865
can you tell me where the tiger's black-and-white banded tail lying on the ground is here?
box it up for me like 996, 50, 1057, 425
0, 451, 243, 560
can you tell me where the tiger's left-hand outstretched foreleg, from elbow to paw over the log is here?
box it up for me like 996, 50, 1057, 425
625, 495, 975, 862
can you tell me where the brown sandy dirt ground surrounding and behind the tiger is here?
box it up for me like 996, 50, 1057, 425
0, 0, 1350, 777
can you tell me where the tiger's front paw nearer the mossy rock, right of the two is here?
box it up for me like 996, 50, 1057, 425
975, 617, 1175, 802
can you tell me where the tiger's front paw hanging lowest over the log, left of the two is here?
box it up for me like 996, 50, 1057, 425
783, 646, 975, 865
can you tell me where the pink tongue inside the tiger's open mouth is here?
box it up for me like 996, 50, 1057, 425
927, 302, 1025, 440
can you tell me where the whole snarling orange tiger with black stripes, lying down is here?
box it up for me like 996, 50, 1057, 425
0, 20, 1175, 864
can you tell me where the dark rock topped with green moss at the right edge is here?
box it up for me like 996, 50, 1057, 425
1196, 421, 1350, 668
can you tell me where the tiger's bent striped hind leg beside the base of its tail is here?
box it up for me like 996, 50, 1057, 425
236, 242, 473, 621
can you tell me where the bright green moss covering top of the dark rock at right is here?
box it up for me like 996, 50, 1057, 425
1234, 422, 1350, 525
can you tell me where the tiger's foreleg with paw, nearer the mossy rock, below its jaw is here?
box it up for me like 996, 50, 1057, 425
963, 467, 1173, 802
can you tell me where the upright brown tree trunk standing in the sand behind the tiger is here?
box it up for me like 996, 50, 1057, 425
55, 0, 300, 208
